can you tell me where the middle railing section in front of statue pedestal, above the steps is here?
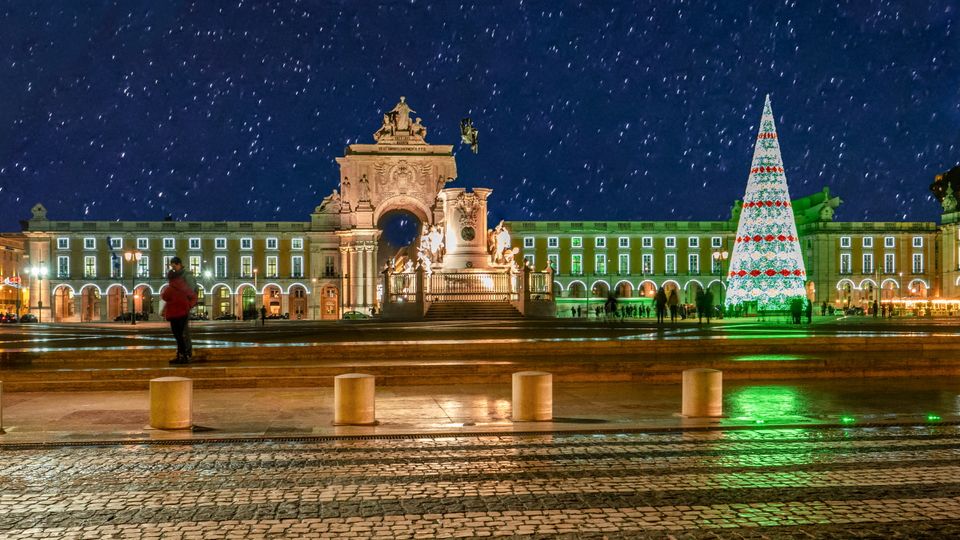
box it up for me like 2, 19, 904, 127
425, 272, 520, 302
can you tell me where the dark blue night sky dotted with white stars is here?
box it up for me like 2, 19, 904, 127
0, 0, 960, 231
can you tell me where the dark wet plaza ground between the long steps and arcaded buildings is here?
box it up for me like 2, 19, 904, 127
0, 317, 960, 352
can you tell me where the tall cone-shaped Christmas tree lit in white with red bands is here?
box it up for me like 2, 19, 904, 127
726, 95, 807, 310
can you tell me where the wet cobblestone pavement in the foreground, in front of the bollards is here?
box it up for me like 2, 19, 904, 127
0, 426, 960, 539
